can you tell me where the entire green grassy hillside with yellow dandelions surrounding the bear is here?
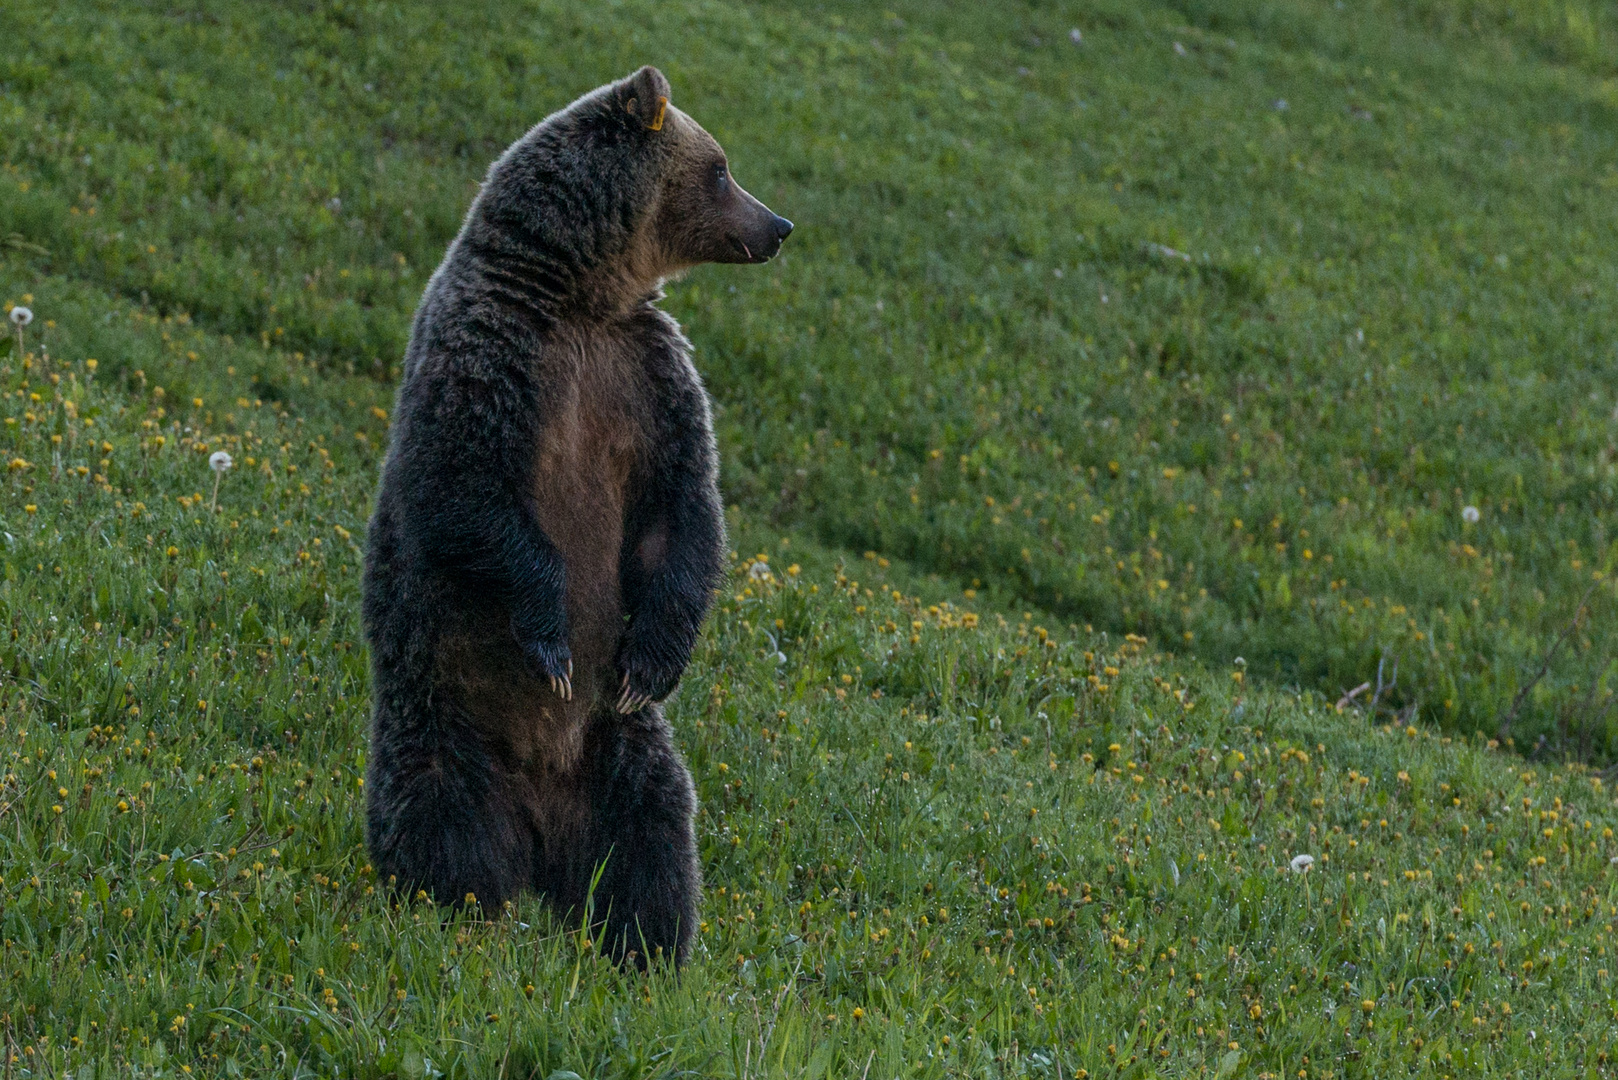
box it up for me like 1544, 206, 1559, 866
0, 0, 1618, 1080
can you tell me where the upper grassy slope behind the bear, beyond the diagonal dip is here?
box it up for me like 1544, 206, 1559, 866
0, 2, 1618, 744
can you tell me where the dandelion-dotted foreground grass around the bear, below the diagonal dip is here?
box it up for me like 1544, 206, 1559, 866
9, 279, 1618, 1077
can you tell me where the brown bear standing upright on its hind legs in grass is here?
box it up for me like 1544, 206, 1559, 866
364, 68, 793, 963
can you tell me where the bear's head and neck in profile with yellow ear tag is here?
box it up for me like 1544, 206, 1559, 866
468, 66, 793, 306
